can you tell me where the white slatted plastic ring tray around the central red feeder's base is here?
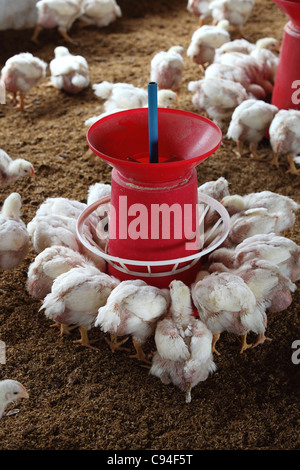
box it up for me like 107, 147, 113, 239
76, 193, 230, 278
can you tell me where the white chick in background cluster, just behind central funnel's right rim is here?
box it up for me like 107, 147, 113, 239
188, 78, 248, 128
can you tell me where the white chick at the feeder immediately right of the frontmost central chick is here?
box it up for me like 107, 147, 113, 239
191, 272, 267, 354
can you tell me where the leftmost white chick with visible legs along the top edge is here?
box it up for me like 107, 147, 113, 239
31, 0, 82, 44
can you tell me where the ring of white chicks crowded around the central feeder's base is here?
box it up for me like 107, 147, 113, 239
0, 164, 300, 402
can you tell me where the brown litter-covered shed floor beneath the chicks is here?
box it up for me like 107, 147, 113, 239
0, 0, 300, 450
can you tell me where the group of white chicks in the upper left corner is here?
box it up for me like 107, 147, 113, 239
1, 0, 122, 111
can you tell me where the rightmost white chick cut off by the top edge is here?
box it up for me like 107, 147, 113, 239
210, 0, 255, 35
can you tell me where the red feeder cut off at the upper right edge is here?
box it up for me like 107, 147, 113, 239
272, 0, 300, 109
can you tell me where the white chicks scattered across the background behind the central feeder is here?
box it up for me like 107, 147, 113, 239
1, 0, 300, 175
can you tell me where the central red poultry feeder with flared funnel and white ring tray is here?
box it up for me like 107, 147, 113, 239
77, 108, 229, 287
